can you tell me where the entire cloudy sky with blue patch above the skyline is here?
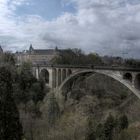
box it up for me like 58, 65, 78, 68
0, 0, 140, 58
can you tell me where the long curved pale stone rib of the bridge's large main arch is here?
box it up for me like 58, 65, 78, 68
58, 70, 140, 99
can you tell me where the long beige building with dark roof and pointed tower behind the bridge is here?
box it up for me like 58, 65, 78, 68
15, 45, 59, 64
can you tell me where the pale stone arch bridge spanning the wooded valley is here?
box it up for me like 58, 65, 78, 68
33, 65, 140, 99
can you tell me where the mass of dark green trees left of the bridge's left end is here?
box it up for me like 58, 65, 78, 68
0, 53, 49, 140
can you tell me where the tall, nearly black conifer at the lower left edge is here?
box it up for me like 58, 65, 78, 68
0, 66, 22, 140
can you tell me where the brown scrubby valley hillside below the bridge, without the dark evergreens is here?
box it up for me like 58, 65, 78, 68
20, 74, 140, 140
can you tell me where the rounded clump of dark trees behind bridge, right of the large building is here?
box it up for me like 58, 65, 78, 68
52, 48, 103, 65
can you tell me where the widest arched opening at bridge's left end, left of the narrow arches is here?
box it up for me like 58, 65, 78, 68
40, 69, 49, 84
